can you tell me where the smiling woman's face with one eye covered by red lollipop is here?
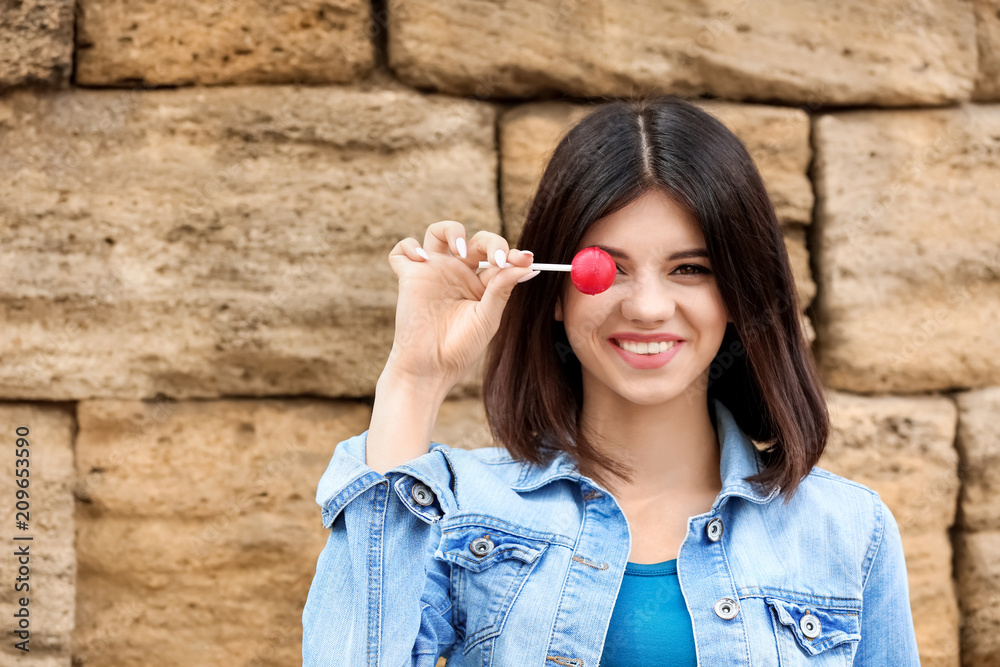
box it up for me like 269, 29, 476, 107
556, 191, 729, 405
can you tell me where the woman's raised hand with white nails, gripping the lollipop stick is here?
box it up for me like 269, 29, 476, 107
386, 220, 538, 392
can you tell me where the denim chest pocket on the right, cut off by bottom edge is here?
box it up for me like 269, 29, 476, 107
765, 597, 861, 667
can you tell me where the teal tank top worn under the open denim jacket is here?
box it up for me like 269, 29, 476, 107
599, 558, 698, 667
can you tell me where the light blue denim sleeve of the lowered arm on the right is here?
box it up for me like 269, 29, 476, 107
854, 499, 920, 667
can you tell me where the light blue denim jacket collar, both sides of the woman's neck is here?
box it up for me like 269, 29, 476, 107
511, 398, 781, 510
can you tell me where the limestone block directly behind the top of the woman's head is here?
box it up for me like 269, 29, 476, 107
500, 102, 813, 239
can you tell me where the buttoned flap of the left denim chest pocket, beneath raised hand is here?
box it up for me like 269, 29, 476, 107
434, 524, 549, 572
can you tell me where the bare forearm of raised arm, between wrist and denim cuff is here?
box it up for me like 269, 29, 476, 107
365, 363, 449, 474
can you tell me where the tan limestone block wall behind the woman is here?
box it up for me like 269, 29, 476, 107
0, 0, 1000, 667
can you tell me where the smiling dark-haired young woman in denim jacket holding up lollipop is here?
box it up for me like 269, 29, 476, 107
302, 97, 919, 667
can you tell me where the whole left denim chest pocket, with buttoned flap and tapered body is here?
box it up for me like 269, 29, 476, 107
435, 524, 549, 653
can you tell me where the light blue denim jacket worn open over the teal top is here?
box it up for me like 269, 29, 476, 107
302, 399, 920, 667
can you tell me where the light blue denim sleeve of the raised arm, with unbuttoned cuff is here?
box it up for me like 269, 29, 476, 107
302, 431, 456, 667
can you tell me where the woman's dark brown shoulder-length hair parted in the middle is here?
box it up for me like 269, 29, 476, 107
483, 95, 829, 501
